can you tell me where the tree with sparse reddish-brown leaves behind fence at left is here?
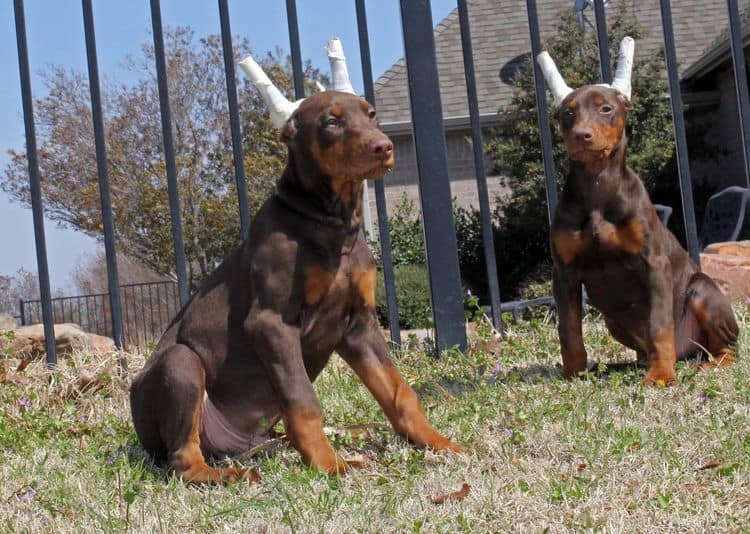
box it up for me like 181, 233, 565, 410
0, 27, 327, 288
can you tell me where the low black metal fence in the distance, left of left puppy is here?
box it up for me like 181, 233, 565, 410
19, 280, 180, 349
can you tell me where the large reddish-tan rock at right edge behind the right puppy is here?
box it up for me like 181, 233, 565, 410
701, 241, 750, 302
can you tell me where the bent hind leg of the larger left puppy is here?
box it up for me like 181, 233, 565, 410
130, 344, 257, 484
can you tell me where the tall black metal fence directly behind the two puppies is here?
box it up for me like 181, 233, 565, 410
14, 0, 750, 362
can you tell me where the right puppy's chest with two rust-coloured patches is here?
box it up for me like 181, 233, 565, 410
552, 210, 648, 265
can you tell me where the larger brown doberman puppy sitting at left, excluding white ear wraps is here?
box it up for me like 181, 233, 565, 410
130, 91, 462, 483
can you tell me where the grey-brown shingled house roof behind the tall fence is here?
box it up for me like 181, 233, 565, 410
375, 0, 748, 125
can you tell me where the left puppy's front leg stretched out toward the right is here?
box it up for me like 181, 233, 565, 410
336, 312, 464, 452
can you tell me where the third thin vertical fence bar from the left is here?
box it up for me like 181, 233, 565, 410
151, 0, 188, 305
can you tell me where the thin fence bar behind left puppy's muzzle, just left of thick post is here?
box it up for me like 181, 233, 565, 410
355, 0, 401, 346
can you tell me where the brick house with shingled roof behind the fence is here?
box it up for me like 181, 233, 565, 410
371, 0, 746, 225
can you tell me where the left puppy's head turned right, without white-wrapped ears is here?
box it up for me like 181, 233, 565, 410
281, 91, 395, 197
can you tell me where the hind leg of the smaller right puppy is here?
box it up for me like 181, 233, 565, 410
688, 272, 739, 369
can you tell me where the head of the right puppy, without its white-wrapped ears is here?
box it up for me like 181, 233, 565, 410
556, 85, 633, 170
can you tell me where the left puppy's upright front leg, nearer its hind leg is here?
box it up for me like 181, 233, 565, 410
245, 310, 348, 475
